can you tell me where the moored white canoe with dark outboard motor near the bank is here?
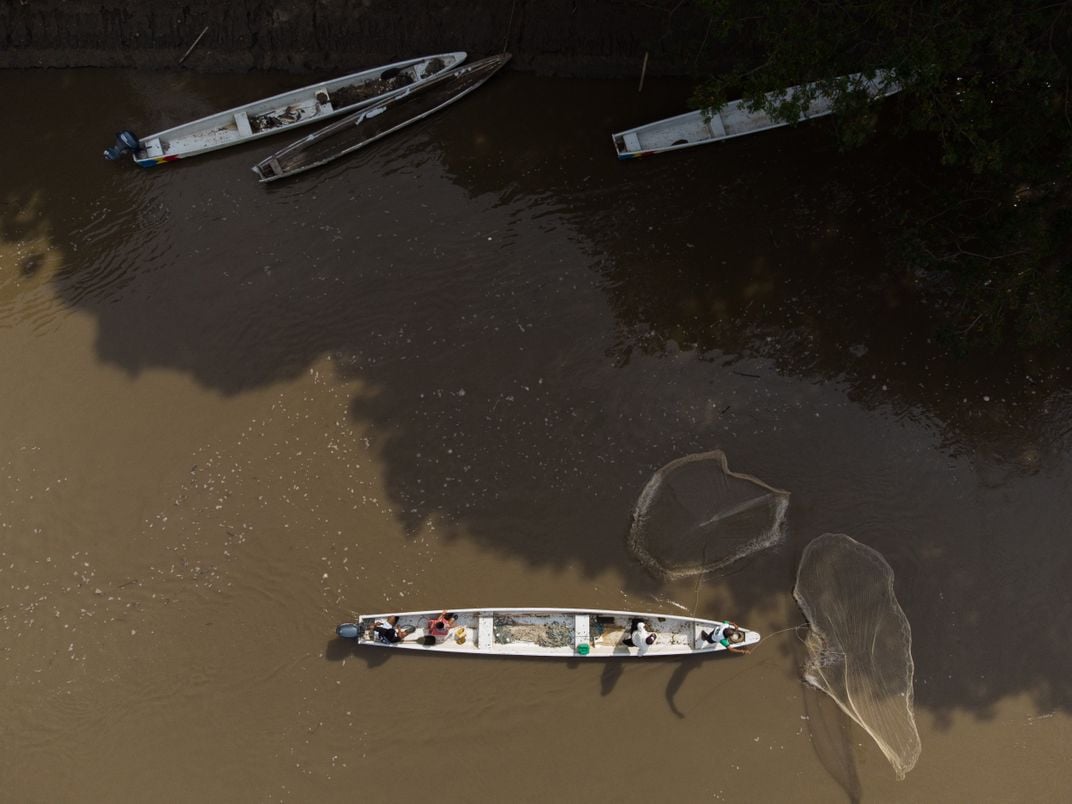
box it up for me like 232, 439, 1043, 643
104, 50, 466, 167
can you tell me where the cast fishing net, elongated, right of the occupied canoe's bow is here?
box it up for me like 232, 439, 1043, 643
793, 533, 921, 778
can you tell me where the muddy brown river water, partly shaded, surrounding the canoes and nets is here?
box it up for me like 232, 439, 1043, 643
0, 71, 1072, 802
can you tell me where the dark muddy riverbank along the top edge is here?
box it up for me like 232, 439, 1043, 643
0, 0, 712, 78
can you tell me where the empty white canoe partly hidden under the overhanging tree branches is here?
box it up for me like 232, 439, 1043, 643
611, 70, 900, 159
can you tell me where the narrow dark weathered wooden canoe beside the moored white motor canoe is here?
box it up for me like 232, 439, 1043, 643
253, 54, 510, 181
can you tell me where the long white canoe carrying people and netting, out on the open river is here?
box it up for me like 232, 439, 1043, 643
336, 608, 760, 658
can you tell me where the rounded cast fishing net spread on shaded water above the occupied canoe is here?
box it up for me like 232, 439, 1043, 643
628, 450, 789, 579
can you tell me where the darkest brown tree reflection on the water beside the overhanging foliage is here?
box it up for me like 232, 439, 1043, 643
436, 74, 1070, 472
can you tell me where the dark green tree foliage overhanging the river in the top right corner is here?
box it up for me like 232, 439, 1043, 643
694, 0, 1072, 342
